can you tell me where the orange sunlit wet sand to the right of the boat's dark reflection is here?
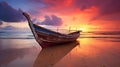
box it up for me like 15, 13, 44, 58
54, 38, 120, 67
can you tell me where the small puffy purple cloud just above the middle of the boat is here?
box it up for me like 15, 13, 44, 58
38, 15, 62, 26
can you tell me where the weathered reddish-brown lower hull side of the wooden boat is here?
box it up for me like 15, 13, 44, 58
36, 31, 79, 48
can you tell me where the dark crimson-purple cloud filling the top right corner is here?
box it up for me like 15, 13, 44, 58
73, 0, 120, 20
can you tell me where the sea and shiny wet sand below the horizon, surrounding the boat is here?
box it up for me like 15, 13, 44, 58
0, 31, 120, 67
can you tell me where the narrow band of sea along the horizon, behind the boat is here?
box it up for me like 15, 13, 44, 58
0, 31, 120, 39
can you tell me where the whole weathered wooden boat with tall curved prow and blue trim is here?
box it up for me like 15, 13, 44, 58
23, 13, 80, 47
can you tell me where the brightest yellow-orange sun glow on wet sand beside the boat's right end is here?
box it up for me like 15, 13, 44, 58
72, 38, 99, 57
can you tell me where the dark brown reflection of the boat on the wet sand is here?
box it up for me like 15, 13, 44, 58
33, 41, 79, 67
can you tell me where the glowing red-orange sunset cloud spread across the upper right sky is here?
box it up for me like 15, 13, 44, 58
27, 0, 120, 28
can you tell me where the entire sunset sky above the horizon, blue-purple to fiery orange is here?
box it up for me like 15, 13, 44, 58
0, 0, 120, 31
